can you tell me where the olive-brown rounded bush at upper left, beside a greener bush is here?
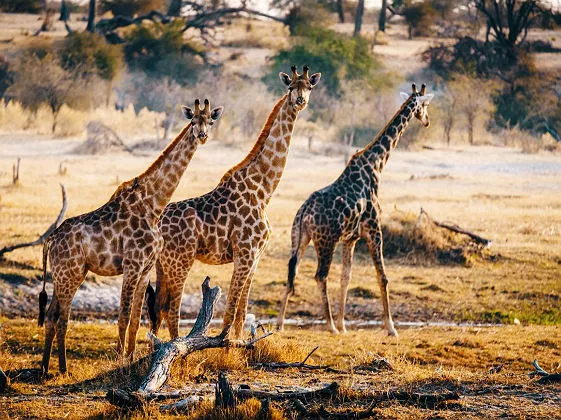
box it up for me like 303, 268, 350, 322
59, 32, 123, 81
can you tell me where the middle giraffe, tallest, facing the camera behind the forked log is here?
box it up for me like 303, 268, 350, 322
152, 66, 321, 338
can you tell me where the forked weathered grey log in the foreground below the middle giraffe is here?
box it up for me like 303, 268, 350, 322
107, 277, 272, 407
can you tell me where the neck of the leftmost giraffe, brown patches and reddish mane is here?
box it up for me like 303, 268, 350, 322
116, 124, 198, 218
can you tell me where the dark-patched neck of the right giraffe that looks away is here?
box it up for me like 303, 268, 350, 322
353, 96, 417, 172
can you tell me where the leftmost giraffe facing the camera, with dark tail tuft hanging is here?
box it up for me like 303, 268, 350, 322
39, 99, 223, 374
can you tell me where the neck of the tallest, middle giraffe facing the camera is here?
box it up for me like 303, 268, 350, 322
221, 95, 298, 205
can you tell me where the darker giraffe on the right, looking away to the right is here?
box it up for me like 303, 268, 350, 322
277, 84, 434, 336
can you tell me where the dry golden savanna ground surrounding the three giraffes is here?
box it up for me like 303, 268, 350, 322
0, 10, 561, 418
